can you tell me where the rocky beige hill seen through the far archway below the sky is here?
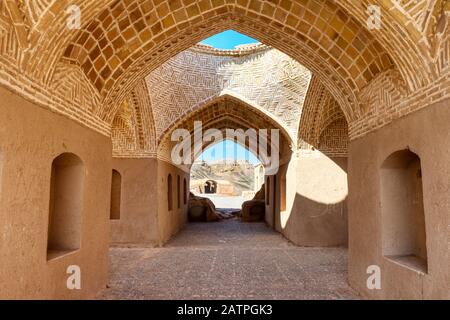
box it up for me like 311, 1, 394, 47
191, 161, 255, 195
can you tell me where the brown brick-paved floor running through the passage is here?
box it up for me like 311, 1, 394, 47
98, 220, 358, 300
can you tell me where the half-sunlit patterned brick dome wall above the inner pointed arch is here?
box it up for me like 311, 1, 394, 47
147, 46, 311, 142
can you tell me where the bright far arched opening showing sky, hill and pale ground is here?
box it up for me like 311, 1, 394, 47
190, 140, 264, 209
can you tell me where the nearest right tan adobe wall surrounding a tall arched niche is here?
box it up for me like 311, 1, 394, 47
349, 99, 450, 299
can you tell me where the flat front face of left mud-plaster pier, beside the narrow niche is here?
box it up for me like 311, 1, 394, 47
111, 158, 159, 246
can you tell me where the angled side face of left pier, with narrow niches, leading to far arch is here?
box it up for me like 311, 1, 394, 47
157, 160, 189, 245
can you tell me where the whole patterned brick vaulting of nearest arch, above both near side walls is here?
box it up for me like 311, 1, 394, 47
0, 0, 450, 154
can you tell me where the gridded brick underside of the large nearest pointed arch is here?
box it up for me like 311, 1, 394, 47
56, 1, 400, 121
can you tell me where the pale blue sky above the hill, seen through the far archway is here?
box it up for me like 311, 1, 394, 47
199, 140, 260, 165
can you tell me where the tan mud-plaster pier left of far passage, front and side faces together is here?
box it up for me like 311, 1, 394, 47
111, 158, 189, 246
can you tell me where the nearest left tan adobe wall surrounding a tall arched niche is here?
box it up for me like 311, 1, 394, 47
0, 87, 112, 299
